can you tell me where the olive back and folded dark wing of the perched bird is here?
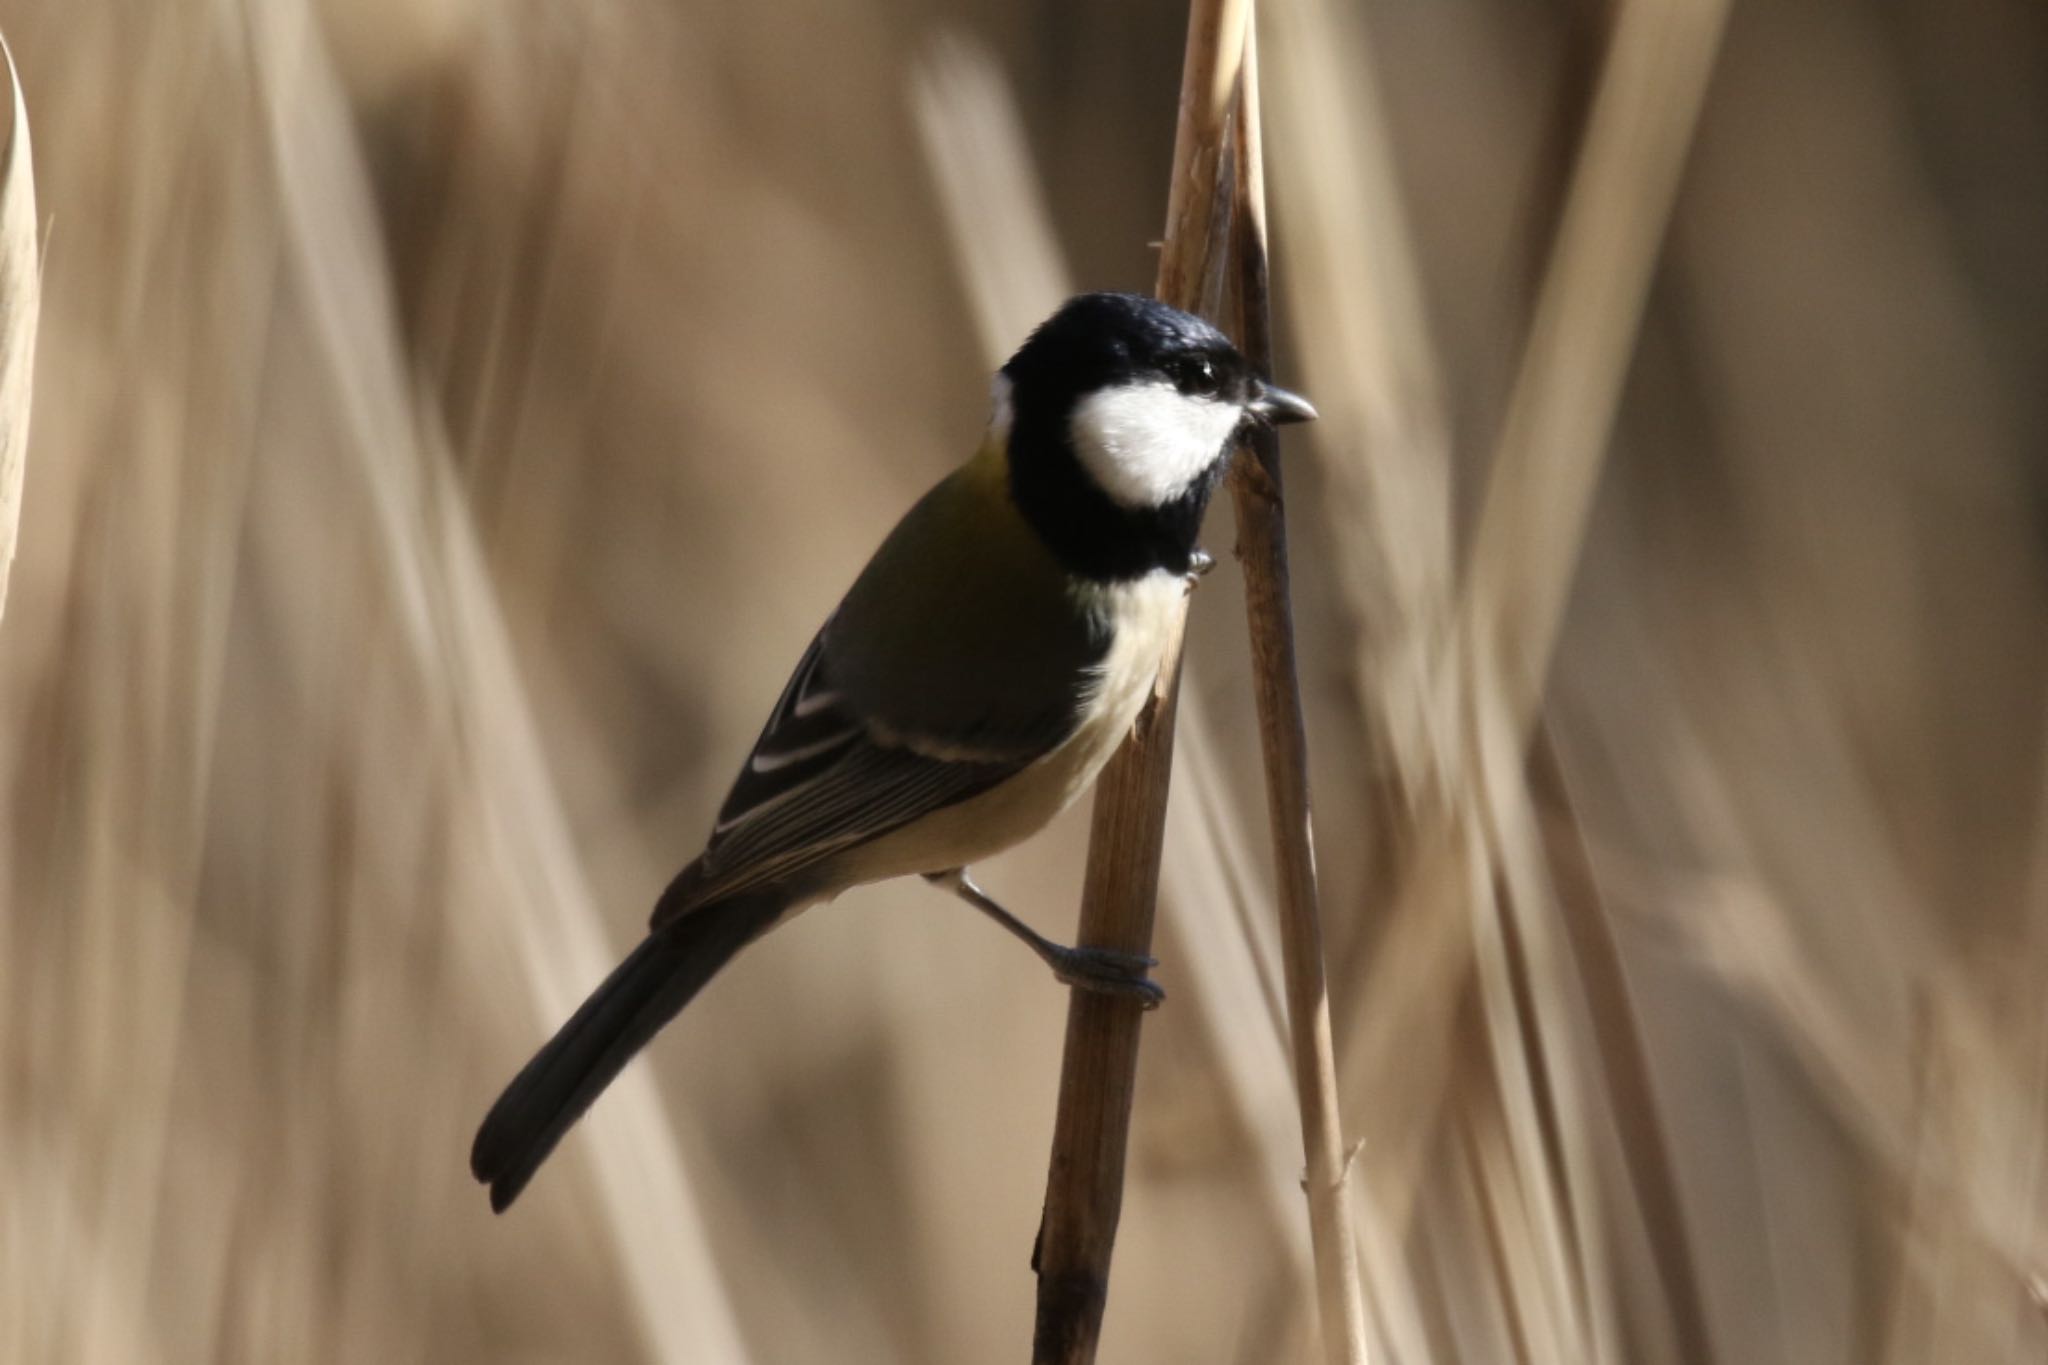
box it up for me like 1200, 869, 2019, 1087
653, 448, 1108, 925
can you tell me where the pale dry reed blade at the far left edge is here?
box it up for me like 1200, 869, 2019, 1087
0, 39, 43, 614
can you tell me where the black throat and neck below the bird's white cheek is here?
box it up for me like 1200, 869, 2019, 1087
1010, 405, 1229, 583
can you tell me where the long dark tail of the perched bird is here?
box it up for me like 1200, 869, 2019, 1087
469, 892, 784, 1214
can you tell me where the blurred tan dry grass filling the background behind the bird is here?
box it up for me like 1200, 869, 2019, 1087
0, 0, 2048, 1365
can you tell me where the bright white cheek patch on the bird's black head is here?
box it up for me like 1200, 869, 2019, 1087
1069, 385, 1243, 508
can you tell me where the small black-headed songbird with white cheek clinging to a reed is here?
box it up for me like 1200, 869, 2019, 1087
469, 295, 1315, 1212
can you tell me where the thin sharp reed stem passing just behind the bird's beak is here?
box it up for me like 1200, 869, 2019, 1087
1231, 33, 1366, 1365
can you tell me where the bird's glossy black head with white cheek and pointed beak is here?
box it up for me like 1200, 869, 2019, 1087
995, 295, 1315, 579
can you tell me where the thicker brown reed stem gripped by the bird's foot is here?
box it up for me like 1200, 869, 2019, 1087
1032, 0, 1249, 1365
